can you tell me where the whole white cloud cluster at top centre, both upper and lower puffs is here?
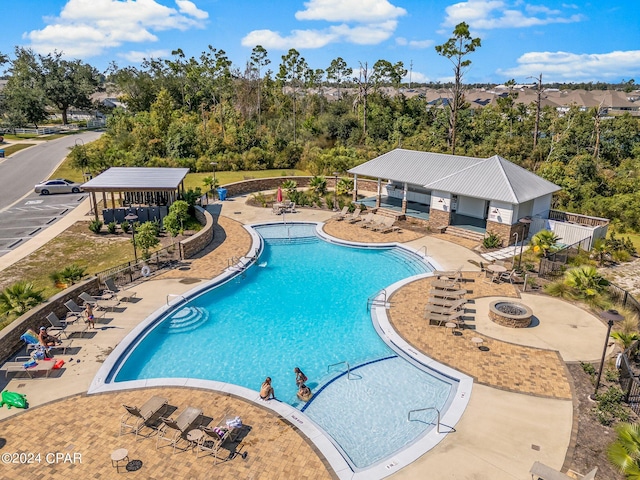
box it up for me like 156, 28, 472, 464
242, 0, 407, 50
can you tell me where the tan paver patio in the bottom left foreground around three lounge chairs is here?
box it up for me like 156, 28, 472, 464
0, 387, 335, 480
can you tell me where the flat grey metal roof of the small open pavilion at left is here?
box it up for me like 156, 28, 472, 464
82, 167, 189, 192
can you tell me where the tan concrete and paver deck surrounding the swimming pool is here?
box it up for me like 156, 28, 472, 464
0, 198, 606, 480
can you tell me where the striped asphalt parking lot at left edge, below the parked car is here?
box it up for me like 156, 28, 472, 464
0, 193, 88, 256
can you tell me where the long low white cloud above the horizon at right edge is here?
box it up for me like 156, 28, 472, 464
497, 50, 640, 82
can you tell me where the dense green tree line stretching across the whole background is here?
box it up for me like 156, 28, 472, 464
0, 23, 640, 231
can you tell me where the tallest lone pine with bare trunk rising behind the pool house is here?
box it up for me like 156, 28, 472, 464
436, 22, 481, 155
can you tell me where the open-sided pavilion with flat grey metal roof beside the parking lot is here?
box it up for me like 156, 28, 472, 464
82, 167, 189, 220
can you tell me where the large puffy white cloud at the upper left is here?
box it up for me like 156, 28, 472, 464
23, 0, 209, 58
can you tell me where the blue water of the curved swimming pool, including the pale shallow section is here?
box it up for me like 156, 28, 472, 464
115, 225, 451, 468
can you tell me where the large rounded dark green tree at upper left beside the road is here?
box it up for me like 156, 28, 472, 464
38, 52, 99, 125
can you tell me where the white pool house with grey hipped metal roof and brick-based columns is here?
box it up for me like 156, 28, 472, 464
348, 148, 608, 248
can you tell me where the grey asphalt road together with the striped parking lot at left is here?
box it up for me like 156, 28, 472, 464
0, 132, 102, 256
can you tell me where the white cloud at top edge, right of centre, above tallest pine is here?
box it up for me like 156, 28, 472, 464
444, 0, 584, 30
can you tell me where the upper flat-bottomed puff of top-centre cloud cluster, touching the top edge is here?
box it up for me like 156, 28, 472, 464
296, 0, 407, 23
